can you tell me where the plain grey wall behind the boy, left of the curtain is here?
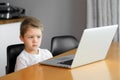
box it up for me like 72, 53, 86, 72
0, 0, 86, 76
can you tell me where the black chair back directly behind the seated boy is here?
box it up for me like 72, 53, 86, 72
6, 44, 24, 74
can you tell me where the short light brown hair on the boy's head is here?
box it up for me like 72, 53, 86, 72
20, 17, 43, 36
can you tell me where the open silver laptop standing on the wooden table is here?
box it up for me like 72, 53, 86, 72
40, 25, 118, 68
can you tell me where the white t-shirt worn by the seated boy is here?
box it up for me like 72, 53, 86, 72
15, 48, 53, 71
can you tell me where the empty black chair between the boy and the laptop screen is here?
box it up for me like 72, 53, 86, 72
51, 35, 78, 56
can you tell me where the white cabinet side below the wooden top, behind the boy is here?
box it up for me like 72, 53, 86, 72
0, 22, 21, 76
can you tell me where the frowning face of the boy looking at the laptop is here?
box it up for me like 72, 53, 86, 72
20, 28, 42, 52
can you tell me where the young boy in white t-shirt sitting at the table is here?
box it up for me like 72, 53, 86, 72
15, 17, 53, 71
